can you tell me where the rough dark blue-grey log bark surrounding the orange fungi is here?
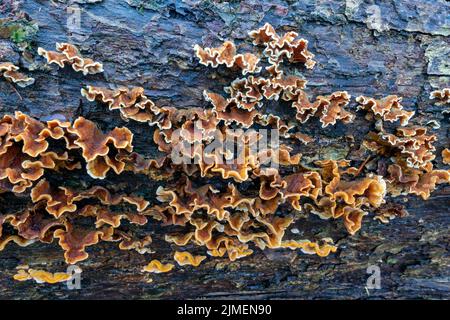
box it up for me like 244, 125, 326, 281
0, 0, 450, 299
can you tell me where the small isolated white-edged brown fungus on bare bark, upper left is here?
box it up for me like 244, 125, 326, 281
38, 43, 103, 76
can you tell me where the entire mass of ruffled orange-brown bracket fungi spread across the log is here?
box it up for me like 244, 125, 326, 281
0, 24, 450, 279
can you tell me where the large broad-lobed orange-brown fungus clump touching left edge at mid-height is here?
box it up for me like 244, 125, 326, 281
0, 112, 139, 193
